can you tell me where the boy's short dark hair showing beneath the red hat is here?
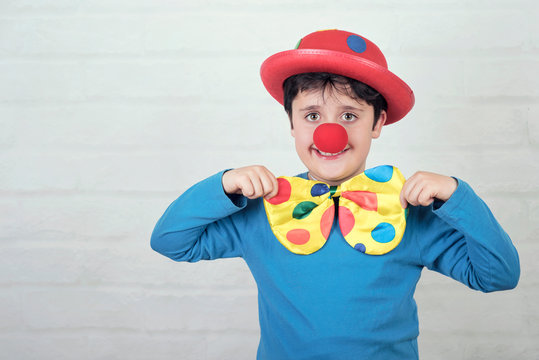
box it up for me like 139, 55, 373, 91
283, 72, 387, 128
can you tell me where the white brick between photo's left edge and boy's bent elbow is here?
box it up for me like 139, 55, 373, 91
0, 195, 163, 240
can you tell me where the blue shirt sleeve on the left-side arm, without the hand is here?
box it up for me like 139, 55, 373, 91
151, 171, 247, 262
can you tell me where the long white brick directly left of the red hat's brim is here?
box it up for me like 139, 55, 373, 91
83, 57, 266, 102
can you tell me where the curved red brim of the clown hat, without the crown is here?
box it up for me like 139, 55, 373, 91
260, 49, 415, 125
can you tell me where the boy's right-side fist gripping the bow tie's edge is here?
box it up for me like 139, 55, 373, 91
400, 171, 458, 209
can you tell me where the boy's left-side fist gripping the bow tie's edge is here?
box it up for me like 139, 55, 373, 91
221, 165, 279, 199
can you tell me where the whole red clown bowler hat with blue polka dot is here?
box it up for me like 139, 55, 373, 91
260, 30, 414, 125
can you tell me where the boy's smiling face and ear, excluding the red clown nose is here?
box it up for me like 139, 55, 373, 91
292, 87, 386, 185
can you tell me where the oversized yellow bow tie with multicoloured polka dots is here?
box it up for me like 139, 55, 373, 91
264, 165, 407, 255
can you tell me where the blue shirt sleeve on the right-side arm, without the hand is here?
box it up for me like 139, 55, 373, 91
414, 179, 520, 292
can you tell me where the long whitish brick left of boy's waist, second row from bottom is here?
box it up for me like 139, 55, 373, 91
23, 288, 258, 331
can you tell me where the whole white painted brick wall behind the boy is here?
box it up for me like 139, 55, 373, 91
0, 0, 539, 360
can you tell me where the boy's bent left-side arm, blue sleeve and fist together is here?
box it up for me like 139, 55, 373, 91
151, 165, 278, 262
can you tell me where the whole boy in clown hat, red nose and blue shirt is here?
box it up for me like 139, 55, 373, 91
151, 30, 520, 359
